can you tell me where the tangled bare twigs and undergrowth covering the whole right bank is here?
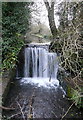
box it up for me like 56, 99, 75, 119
51, 2, 83, 107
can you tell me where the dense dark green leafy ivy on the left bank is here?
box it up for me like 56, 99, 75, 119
2, 2, 30, 69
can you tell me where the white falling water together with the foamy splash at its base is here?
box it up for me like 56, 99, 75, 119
22, 46, 59, 86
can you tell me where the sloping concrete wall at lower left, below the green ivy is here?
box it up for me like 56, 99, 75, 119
0, 69, 15, 120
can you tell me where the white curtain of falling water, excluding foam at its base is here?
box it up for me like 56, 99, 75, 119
24, 47, 58, 78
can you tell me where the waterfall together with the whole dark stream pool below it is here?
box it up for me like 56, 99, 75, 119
3, 45, 81, 120
